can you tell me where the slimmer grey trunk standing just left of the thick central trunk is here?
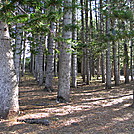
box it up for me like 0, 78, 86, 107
45, 22, 55, 92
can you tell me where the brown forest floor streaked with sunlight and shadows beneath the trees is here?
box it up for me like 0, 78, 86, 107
0, 74, 134, 134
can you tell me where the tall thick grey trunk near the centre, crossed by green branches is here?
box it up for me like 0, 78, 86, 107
57, 0, 72, 102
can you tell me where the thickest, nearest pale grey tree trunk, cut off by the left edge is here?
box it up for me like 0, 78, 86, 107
0, 21, 19, 119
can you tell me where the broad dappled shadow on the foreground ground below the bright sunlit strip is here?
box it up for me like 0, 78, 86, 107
0, 101, 134, 134
